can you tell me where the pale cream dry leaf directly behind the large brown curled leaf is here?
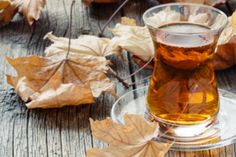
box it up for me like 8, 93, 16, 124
45, 32, 119, 56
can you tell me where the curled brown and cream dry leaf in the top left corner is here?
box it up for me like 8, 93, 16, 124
0, 0, 45, 25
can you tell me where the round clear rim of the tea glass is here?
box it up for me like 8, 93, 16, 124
142, 3, 228, 35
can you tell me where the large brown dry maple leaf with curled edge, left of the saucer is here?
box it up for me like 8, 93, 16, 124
7, 52, 114, 108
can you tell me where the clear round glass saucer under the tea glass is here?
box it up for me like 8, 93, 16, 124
111, 86, 236, 151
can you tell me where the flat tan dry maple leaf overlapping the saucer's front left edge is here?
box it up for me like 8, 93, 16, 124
87, 115, 172, 157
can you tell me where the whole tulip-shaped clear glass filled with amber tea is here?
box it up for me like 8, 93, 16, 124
143, 3, 228, 137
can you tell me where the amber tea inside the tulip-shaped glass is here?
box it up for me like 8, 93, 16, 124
147, 23, 219, 125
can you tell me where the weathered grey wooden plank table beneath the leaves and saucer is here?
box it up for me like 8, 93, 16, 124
0, 0, 236, 157
